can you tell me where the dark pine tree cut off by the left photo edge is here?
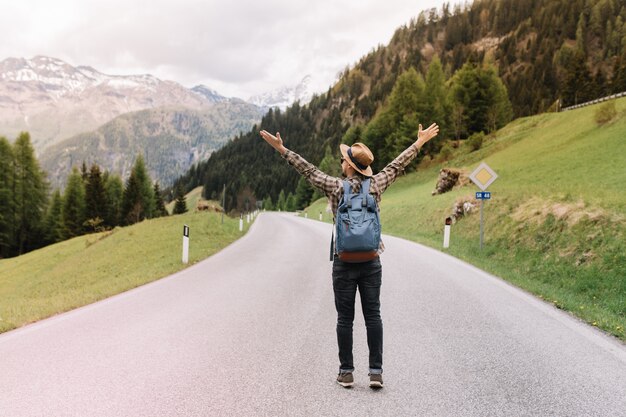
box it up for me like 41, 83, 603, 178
0, 137, 15, 258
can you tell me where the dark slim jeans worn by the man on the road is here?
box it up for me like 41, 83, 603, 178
333, 257, 383, 374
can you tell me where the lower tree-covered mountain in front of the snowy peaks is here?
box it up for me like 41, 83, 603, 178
39, 99, 262, 188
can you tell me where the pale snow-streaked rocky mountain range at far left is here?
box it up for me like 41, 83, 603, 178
0, 56, 228, 153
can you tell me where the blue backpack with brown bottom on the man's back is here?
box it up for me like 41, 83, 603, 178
335, 178, 380, 262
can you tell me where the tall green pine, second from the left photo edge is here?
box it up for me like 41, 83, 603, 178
13, 132, 47, 255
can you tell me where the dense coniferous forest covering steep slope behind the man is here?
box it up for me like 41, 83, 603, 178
171, 0, 626, 210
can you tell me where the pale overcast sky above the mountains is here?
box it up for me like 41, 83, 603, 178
0, 0, 448, 99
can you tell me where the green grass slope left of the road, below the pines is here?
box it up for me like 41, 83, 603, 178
0, 212, 249, 333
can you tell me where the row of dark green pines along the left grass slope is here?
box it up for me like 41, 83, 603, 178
0, 132, 176, 258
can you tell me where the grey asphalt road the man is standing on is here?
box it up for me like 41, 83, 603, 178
0, 214, 626, 417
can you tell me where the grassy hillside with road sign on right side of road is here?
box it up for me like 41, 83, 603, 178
309, 99, 626, 340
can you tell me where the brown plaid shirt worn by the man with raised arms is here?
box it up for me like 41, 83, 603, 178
283, 144, 419, 254
